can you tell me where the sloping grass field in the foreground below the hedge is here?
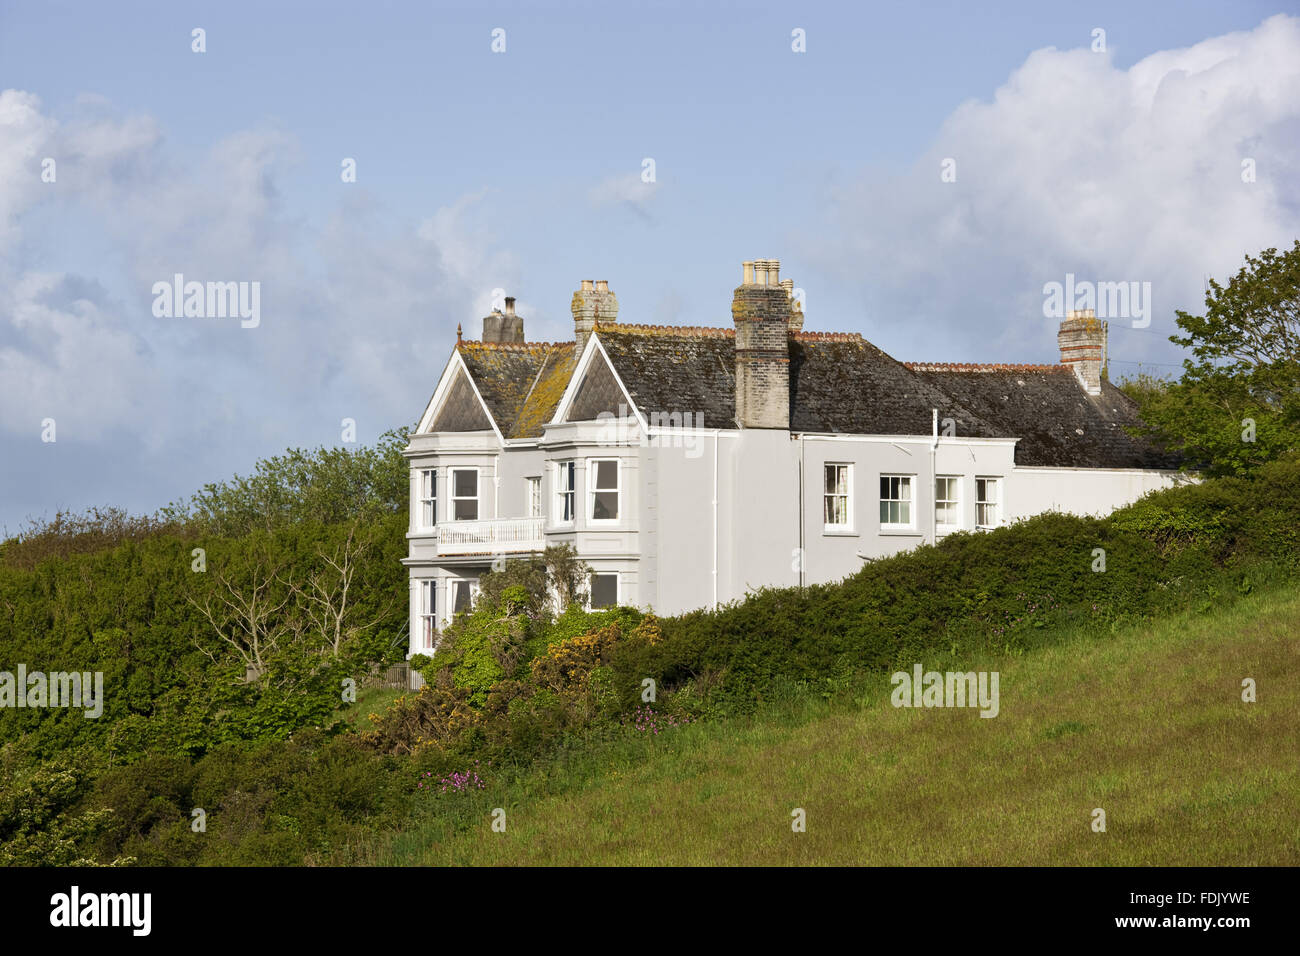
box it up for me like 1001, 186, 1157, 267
350, 592, 1300, 865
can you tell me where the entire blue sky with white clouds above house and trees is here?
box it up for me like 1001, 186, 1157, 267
0, 0, 1300, 532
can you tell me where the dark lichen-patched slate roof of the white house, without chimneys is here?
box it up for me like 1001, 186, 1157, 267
444, 324, 1178, 468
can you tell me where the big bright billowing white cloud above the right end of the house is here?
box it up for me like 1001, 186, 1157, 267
803, 16, 1300, 360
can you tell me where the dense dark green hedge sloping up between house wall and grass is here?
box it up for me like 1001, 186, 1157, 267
612, 460, 1300, 709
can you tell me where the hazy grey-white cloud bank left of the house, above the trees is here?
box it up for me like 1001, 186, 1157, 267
0, 90, 516, 527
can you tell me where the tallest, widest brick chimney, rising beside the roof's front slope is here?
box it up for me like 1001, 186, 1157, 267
732, 259, 792, 428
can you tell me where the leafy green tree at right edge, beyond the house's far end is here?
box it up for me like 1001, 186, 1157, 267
1123, 239, 1300, 475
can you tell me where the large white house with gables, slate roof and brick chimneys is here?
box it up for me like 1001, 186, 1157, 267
404, 260, 1177, 653
